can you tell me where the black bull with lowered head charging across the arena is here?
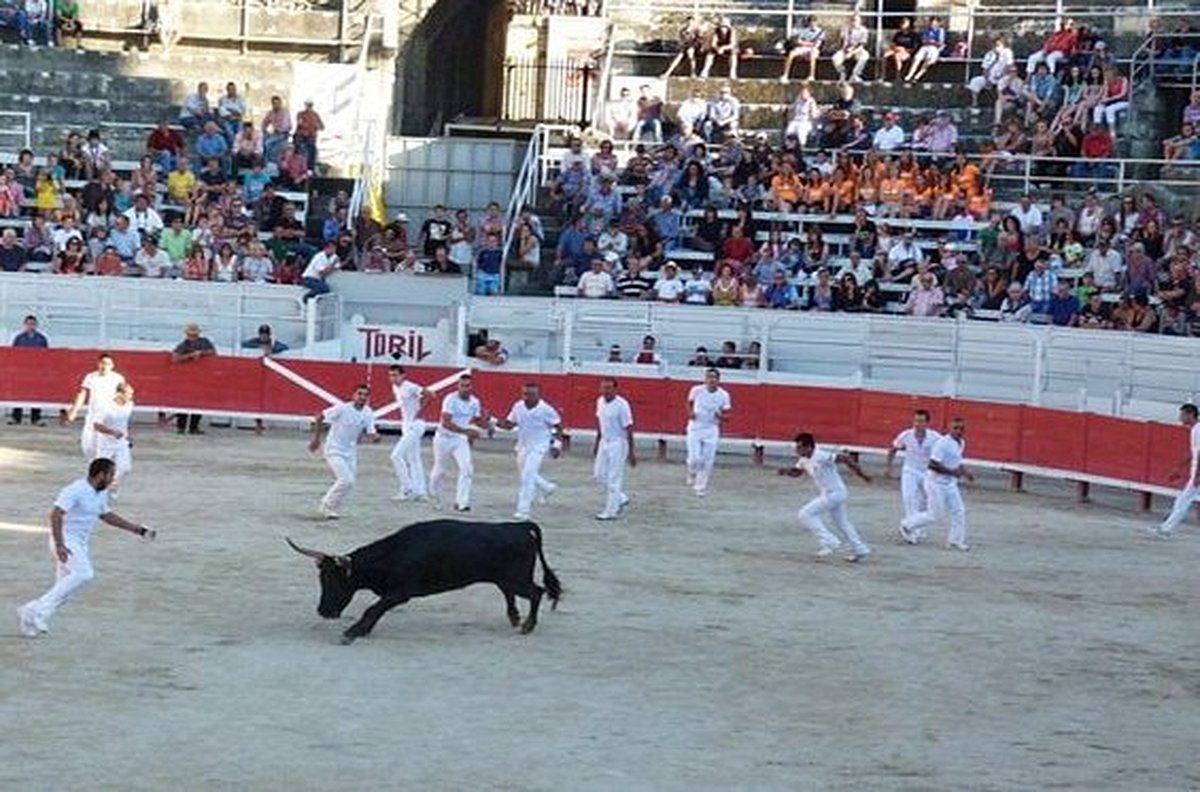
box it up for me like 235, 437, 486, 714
287, 520, 563, 643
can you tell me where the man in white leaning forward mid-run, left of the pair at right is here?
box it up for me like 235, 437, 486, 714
779, 432, 871, 562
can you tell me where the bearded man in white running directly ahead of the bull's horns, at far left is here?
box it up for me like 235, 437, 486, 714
17, 458, 156, 638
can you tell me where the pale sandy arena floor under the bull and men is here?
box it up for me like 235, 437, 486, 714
0, 427, 1200, 791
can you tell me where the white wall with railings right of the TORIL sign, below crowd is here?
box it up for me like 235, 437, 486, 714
466, 296, 1200, 419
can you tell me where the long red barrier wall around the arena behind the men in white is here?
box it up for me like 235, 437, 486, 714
0, 348, 1188, 486
